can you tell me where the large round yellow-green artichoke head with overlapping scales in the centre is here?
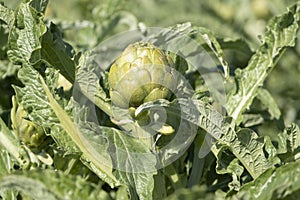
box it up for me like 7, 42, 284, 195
108, 42, 178, 108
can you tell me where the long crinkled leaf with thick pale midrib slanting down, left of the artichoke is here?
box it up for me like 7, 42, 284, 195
15, 66, 117, 186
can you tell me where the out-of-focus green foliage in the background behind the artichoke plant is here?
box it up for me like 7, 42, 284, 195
0, 0, 300, 132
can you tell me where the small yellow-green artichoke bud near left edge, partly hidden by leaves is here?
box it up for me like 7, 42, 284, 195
11, 97, 46, 147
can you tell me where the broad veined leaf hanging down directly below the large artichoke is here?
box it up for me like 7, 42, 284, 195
110, 130, 157, 199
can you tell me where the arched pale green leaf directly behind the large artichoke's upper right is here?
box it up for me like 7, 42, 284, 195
148, 22, 229, 78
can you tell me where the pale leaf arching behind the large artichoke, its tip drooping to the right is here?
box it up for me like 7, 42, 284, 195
146, 22, 229, 85
